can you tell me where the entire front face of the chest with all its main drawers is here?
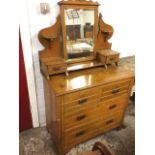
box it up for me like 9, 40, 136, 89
63, 79, 130, 150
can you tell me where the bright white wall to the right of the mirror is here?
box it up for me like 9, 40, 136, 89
98, 0, 135, 57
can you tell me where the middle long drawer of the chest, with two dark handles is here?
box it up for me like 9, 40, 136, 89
64, 94, 128, 129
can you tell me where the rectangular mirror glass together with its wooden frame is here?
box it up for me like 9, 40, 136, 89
61, 1, 98, 62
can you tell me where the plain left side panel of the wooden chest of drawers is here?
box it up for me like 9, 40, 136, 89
44, 78, 63, 154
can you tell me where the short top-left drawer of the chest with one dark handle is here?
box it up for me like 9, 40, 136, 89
64, 87, 101, 104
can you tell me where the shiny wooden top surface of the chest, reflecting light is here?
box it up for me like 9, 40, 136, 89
48, 55, 134, 95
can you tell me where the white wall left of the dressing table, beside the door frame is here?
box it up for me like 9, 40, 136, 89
25, 0, 59, 126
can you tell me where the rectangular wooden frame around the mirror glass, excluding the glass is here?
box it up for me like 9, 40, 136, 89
60, 4, 98, 64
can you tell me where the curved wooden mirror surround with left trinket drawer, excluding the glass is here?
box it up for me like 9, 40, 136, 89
38, 0, 114, 79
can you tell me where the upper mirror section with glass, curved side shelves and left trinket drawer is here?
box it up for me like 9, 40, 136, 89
38, 0, 113, 78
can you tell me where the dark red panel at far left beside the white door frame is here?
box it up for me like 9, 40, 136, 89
19, 31, 32, 131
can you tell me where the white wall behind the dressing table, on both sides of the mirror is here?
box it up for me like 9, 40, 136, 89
22, 0, 135, 126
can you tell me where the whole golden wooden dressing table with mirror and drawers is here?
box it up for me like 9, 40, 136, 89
38, 0, 134, 155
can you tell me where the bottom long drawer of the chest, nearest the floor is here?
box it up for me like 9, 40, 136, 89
65, 111, 123, 147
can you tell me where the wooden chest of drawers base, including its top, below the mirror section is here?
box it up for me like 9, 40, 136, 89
43, 67, 134, 154
